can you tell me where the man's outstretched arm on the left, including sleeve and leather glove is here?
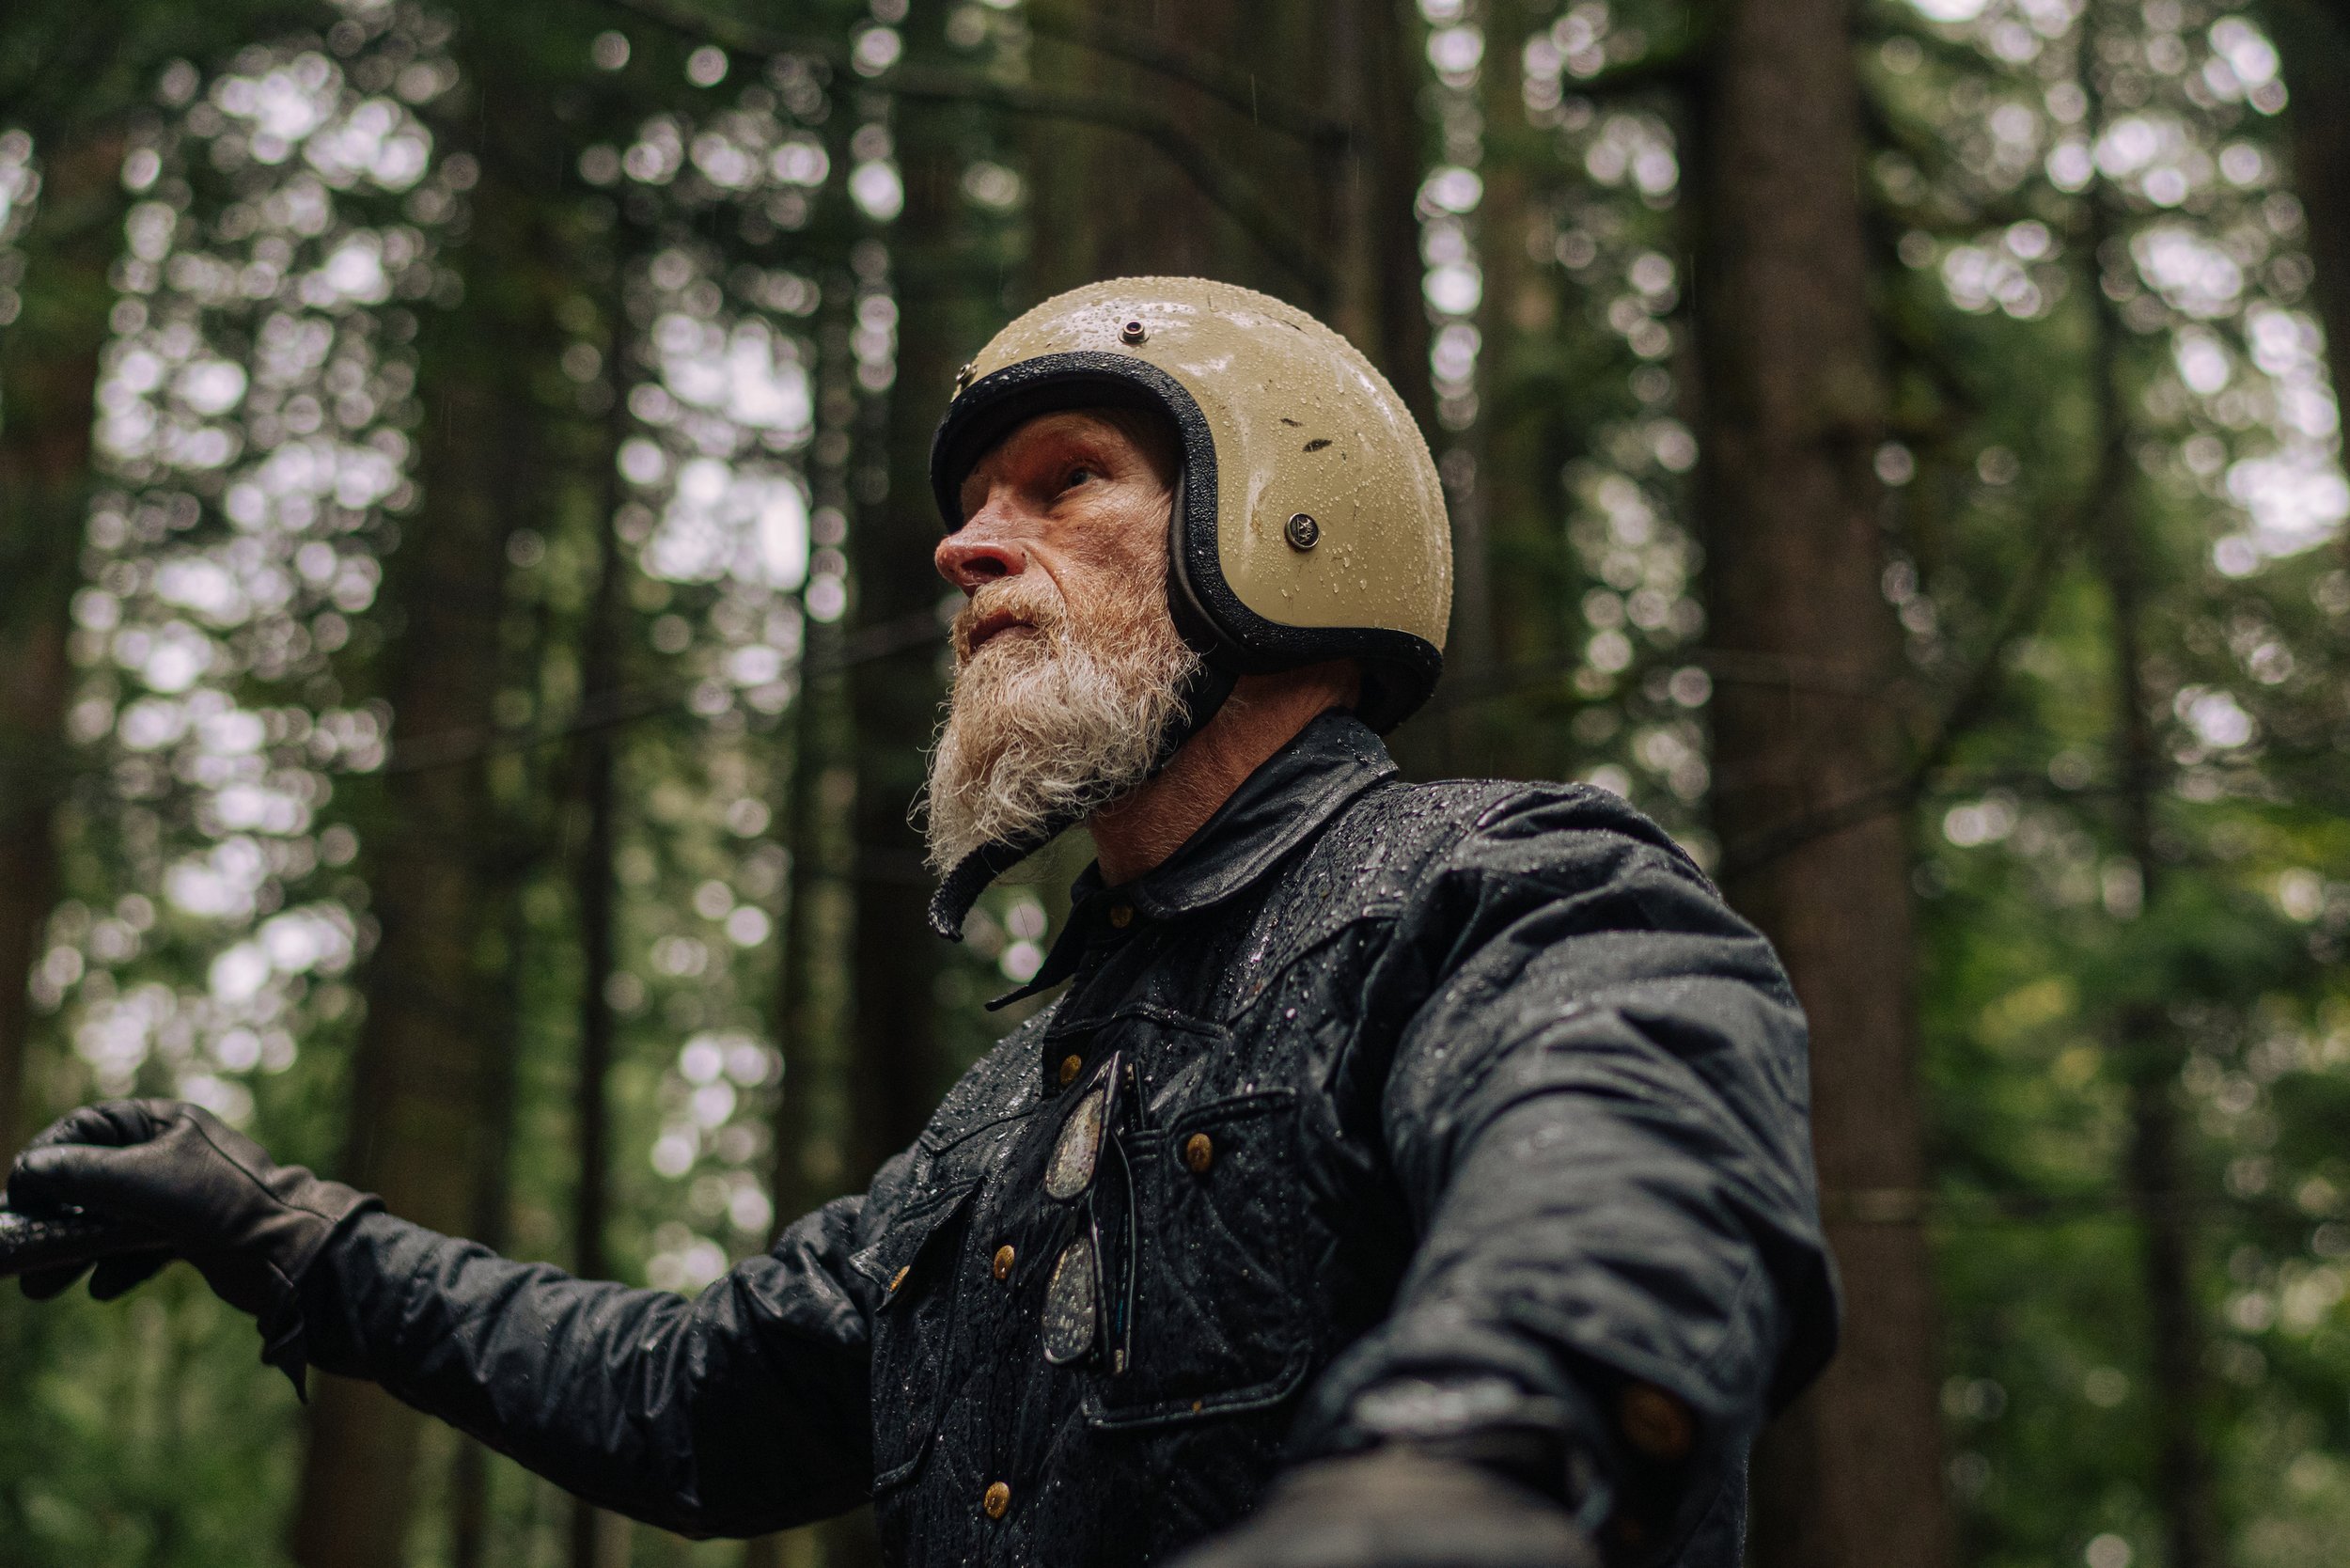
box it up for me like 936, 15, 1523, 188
8, 1100, 902, 1535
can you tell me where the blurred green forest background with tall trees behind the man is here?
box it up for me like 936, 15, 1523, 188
0, 0, 2350, 1568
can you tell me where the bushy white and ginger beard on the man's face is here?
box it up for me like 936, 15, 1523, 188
924, 569, 1198, 874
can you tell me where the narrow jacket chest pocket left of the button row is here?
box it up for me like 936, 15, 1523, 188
849, 1180, 980, 1493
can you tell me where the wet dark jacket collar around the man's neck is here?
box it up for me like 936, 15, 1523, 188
987, 710, 1396, 1009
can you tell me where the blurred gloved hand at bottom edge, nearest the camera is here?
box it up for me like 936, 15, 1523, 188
1175, 1443, 1601, 1568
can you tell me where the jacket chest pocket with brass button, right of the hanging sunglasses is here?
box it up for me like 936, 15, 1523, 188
1086, 1089, 1314, 1427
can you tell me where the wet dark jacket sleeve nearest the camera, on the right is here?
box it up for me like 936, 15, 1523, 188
1300, 788, 1836, 1532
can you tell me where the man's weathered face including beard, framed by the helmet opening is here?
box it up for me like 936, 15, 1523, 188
929, 412, 1198, 870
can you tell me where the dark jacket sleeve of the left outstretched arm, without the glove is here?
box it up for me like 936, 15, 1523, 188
301, 1156, 905, 1537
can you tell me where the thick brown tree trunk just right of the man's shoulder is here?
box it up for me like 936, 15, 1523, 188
1695, 0, 1950, 1568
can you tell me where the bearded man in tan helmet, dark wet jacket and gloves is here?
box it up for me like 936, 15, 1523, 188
9, 280, 1836, 1568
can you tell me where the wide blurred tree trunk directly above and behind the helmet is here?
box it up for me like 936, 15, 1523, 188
1023, 0, 1434, 404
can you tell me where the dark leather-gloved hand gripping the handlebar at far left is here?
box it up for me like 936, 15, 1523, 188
8, 1100, 376, 1325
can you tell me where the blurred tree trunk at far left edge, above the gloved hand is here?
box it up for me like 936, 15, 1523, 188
0, 132, 122, 1168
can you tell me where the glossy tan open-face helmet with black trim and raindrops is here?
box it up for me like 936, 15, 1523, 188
931, 277, 1452, 731
